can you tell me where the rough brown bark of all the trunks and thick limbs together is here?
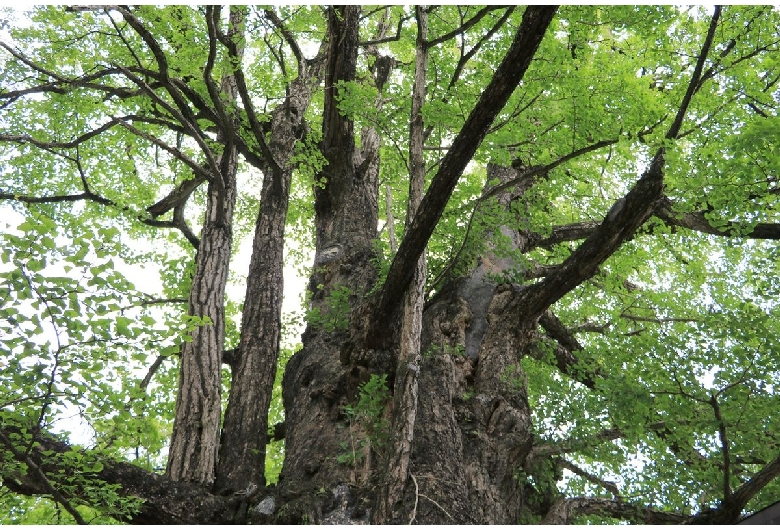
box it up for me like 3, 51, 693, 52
10, 6, 780, 524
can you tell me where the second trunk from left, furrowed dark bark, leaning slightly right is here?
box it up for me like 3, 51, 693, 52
216, 65, 314, 493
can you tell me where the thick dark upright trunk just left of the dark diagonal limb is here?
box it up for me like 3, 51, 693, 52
280, 6, 378, 506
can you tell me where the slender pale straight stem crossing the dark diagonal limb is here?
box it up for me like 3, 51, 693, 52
374, 6, 428, 523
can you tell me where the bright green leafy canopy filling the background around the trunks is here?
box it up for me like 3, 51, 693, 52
0, 5, 780, 523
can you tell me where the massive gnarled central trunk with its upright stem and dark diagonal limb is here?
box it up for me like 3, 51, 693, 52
272, 6, 554, 523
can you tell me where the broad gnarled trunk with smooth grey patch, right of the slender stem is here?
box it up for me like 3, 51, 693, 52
396, 166, 535, 524
